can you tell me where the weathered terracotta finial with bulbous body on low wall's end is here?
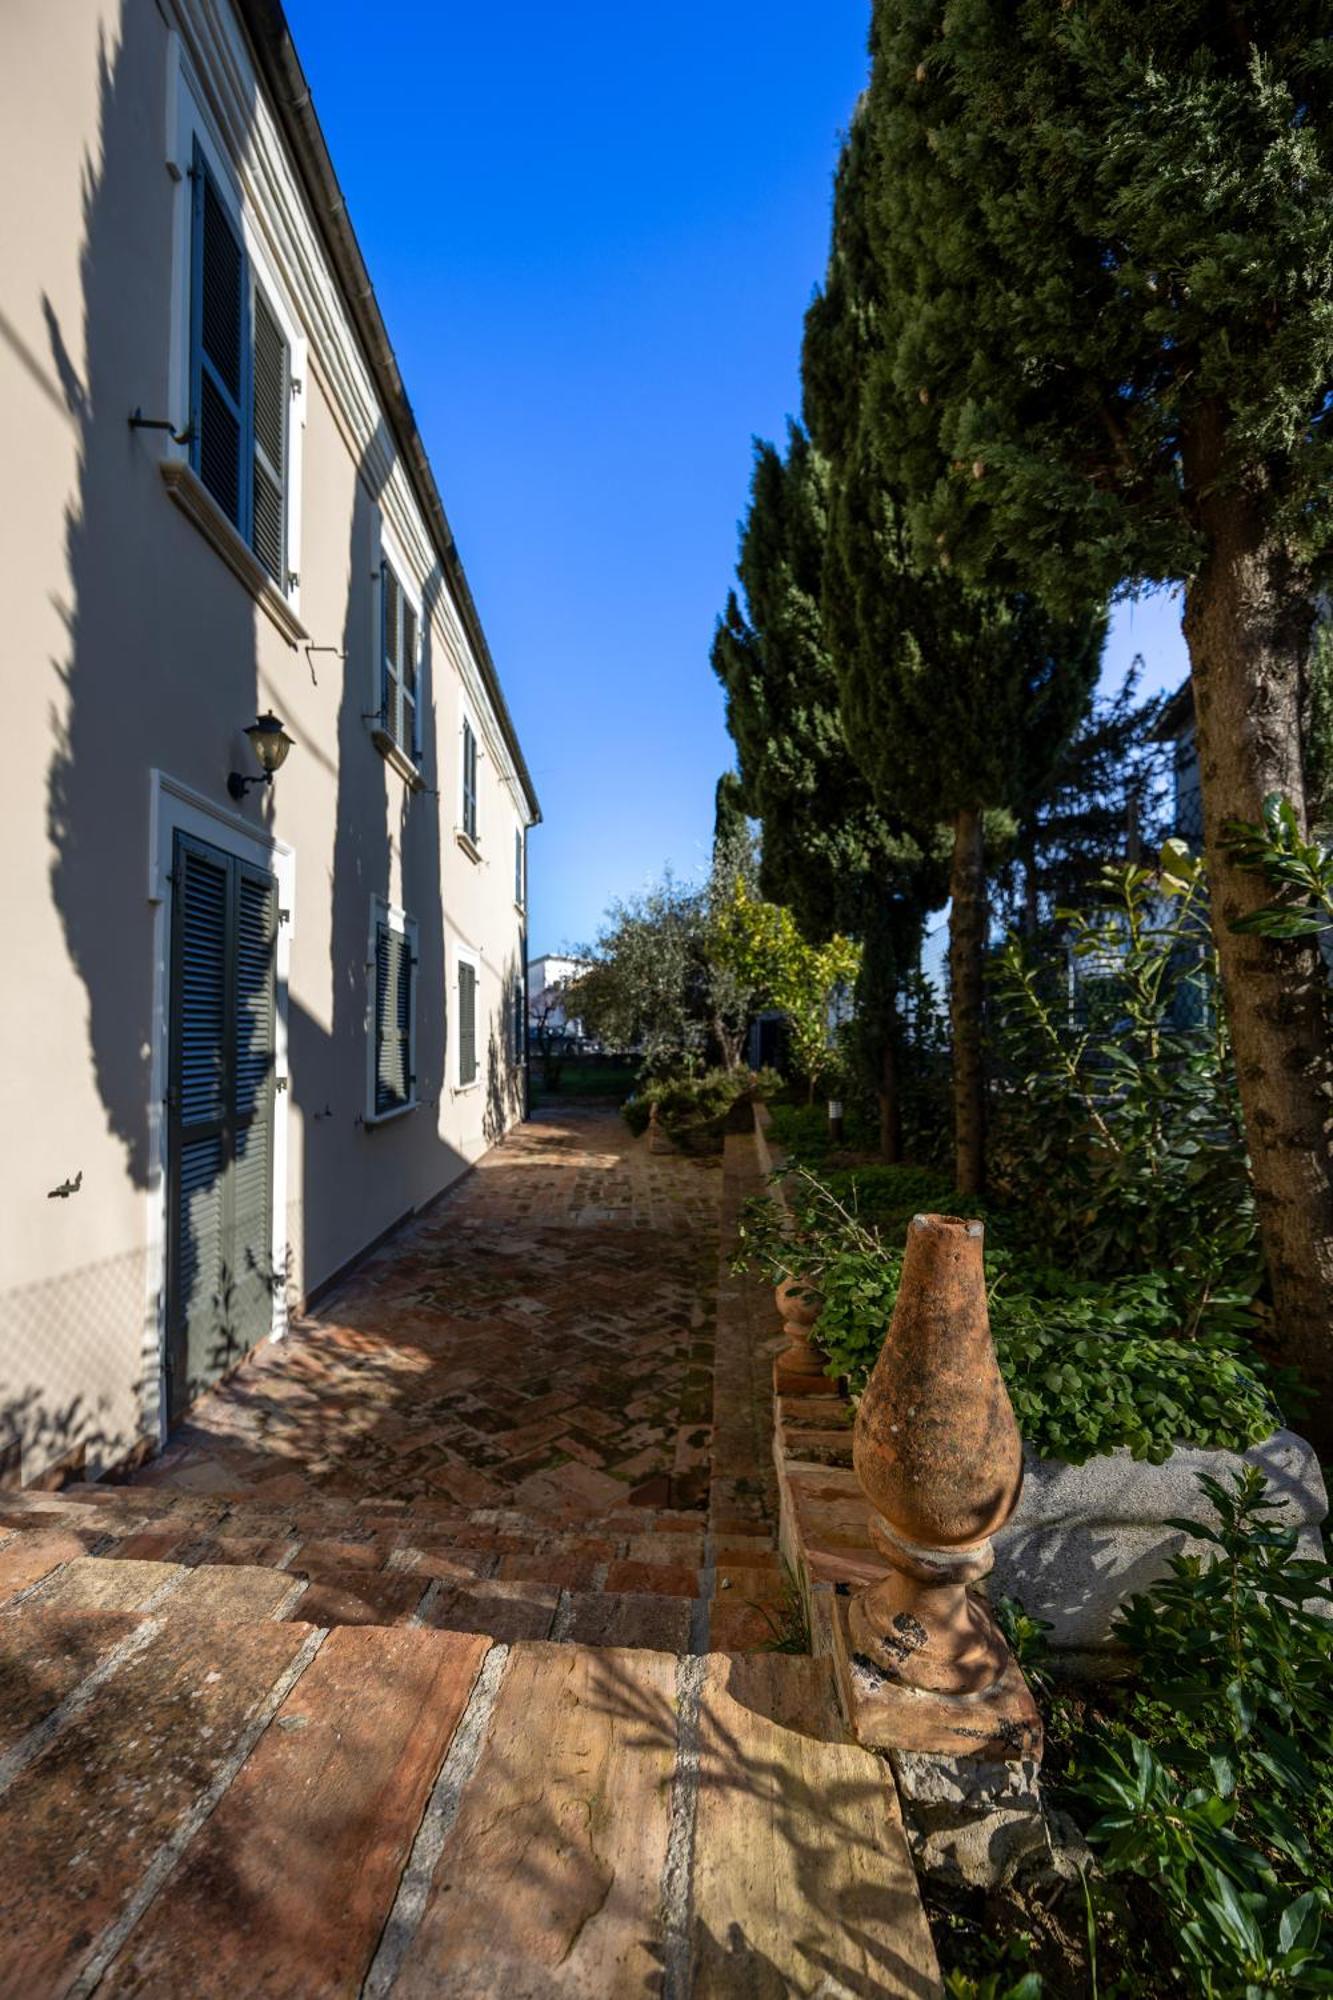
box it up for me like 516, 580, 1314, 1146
849, 1216, 1023, 1698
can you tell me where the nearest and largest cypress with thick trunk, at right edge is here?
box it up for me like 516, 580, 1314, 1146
856, 0, 1333, 1440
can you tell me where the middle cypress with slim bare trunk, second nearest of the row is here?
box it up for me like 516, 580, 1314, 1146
803, 106, 1105, 1194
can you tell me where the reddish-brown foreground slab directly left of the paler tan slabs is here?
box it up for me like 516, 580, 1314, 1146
98, 1626, 486, 2000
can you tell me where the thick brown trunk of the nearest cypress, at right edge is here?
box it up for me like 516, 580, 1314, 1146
1185, 418, 1333, 1452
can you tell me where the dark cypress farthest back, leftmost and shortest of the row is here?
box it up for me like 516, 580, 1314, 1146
713, 424, 943, 1160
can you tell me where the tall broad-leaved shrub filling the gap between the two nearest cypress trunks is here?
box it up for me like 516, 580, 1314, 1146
991, 840, 1261, 1324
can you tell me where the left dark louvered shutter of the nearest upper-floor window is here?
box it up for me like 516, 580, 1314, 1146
190, 146, 248, 532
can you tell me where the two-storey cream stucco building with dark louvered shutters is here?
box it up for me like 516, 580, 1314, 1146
0, 0, 538, 1484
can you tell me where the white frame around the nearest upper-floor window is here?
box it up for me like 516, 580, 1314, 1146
166, 41, 310, 614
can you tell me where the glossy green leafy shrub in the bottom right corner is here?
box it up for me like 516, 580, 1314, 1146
1071, 1468, 1333, 2000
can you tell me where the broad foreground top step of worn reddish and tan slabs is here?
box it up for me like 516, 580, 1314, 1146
0, 1600, 939, 2000
